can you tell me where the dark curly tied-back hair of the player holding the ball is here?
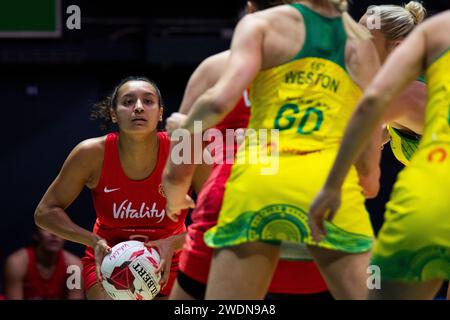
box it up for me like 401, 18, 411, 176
90, 76, 164, 130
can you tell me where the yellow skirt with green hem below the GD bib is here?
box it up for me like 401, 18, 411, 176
205, 149, 374, 253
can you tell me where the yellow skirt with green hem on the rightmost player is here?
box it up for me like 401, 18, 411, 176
371, 145, 450, 282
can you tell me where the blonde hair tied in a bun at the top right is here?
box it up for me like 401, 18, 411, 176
369, 1, 427, 41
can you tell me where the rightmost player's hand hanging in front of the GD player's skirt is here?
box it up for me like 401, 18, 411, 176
309, 187, 341, 242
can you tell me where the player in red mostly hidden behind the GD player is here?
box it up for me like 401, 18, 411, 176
162, 0, 331, 300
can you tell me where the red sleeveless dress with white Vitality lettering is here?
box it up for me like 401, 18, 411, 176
82, 132, 187, 295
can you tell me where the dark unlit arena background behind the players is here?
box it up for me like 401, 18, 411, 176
0, 0, 449, 298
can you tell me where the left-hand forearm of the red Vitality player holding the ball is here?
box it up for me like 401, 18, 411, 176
34, 205, 99, 247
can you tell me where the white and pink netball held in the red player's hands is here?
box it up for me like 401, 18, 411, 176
101, 241, 161, 300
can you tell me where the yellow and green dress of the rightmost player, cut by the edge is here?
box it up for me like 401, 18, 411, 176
372, 49, 450, 282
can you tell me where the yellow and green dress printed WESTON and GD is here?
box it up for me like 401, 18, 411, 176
205, 4, 373, 253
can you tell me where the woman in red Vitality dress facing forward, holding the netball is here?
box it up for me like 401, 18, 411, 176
35, 77, 204, 299
